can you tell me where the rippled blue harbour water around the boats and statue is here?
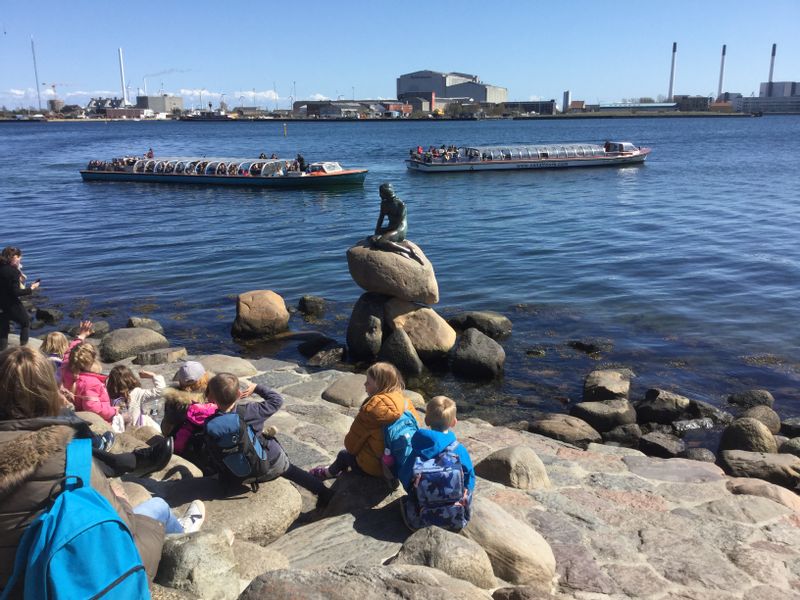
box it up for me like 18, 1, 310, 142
0, 116, 800, 436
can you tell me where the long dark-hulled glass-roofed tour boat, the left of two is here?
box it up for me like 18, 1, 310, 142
80, 156, 367, 188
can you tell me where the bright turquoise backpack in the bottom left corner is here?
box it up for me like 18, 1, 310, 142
0, 438, 150, 600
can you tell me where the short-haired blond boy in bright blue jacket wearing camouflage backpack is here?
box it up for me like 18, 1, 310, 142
398, 396, 475, 530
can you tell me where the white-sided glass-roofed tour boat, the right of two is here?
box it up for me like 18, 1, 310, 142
406, 142, 650, 173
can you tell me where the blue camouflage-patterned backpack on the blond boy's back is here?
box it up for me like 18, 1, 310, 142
405, 441, 471, 531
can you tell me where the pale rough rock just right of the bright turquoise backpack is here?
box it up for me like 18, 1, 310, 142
156, 530, 239, 600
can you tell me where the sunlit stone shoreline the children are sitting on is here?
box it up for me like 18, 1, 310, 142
7, 328, 800, 600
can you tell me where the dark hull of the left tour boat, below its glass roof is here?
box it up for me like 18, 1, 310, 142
81, 169, 367, 189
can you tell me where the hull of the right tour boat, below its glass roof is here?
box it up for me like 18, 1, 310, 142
406, 151, 649, 173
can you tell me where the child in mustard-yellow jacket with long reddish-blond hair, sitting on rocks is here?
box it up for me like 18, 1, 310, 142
310, 362, 419, 479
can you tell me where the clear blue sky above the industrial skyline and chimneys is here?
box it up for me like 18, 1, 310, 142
0, 0, 800, 108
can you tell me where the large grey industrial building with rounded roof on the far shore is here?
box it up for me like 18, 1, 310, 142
397, 71, 508, 105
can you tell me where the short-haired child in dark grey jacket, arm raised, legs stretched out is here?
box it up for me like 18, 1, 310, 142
206, 373, 333, 506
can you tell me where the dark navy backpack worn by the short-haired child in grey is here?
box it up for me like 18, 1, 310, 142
205, 411, 270, 492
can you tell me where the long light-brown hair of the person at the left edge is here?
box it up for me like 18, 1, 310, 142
0, 346, 62, 421
